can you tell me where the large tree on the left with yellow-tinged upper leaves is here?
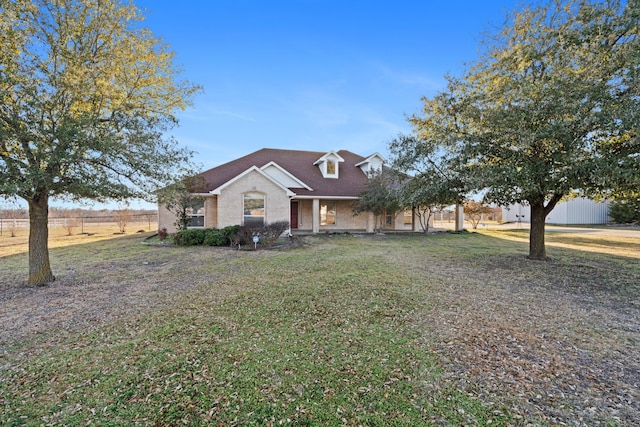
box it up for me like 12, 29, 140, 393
0, 0, 199, 285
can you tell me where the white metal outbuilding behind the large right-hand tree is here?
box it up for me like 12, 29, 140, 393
502, 197, 609, 225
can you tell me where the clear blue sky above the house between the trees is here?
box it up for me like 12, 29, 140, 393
136, 0, 518, 169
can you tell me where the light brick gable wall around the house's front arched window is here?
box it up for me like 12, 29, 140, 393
218, 171, 290, 228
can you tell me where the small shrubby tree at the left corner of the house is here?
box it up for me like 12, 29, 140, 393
158, 175, 207, 231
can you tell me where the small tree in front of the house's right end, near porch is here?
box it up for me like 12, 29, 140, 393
389, 135, 465, 233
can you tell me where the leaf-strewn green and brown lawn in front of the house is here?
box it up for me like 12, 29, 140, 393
0, 232, 640, 426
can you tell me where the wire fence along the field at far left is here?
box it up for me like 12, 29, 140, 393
0, 213, 158, 236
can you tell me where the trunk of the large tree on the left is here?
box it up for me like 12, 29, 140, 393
28, 194, 55, 286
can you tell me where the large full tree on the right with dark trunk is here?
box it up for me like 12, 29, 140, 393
410, 0, 640, 260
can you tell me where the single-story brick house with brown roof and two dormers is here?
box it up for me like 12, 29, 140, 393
158, 148, 416, 233
